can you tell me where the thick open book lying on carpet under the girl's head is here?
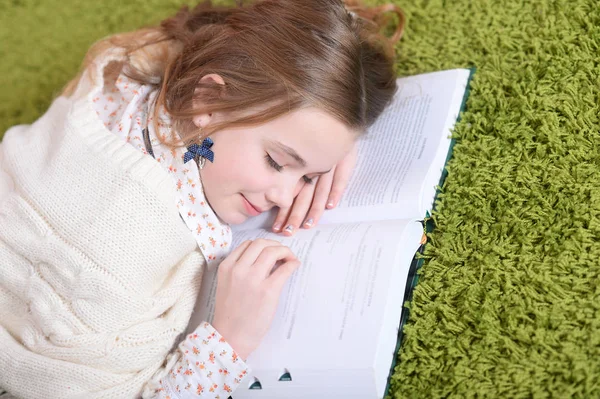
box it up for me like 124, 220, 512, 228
188, 69, 472, 399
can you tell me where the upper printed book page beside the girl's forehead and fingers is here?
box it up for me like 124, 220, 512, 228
234, 69, 470, 230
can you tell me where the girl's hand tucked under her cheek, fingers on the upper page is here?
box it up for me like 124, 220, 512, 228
273, 144, 358, 236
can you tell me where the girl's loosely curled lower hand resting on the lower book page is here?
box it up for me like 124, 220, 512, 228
212, 238, 300, 360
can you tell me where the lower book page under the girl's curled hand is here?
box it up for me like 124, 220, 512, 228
188, 220, 423, 380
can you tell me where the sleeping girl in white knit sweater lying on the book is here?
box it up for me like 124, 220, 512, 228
0, 0, 404, 398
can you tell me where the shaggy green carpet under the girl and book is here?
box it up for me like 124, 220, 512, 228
0, 0, 600, 398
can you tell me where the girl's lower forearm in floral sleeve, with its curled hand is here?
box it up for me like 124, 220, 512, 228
143, 239, 300, 399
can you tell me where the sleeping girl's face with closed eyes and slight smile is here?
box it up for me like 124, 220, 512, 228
194, 108, 357, 224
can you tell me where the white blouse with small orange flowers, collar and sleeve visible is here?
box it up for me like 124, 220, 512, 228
93, 69, 249, 399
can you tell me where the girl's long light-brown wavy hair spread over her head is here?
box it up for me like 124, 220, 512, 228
62, 0, 405, 145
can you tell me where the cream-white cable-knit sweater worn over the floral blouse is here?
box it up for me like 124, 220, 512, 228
0, 52, 211, 398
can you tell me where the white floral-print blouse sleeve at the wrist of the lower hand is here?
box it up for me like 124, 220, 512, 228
142, 322, 249, 399
